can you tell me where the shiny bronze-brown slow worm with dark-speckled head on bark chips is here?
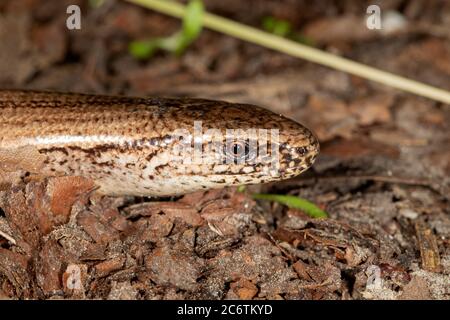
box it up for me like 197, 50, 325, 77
0, 90, 319, 196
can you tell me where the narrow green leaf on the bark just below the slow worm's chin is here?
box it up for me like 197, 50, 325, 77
252, 193, 328, 218
